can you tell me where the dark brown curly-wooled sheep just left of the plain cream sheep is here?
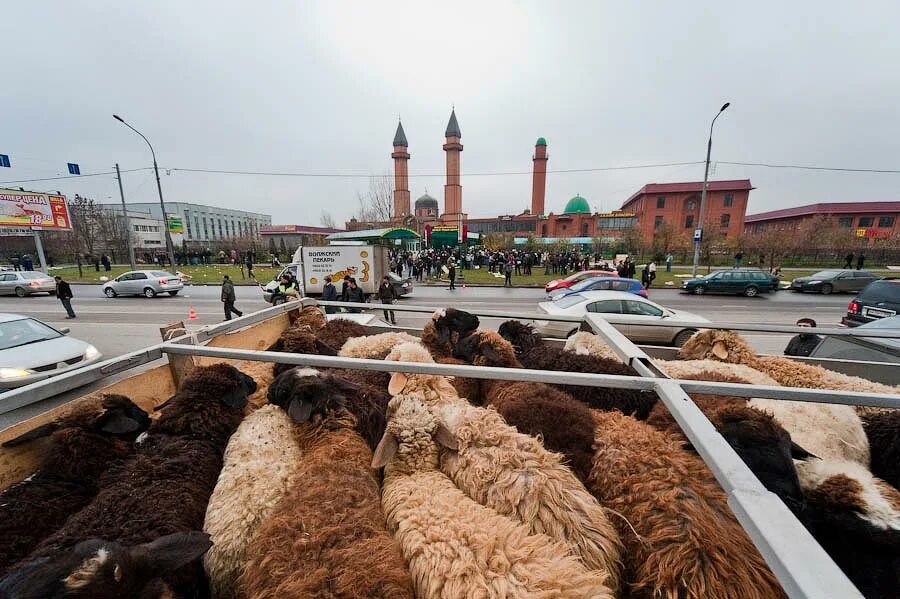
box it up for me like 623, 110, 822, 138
29, 364, 256, 597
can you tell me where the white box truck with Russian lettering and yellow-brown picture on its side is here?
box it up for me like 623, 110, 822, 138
263, 245, 388, 302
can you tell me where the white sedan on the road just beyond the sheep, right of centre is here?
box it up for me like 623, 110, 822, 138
535, 291, 709, 347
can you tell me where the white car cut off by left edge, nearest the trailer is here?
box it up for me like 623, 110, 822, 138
0, 314, 103, 389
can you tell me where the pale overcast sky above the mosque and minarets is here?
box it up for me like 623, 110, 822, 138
0, 0, 900, 225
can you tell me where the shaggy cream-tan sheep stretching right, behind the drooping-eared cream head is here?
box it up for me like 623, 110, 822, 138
387, 342, 621, 589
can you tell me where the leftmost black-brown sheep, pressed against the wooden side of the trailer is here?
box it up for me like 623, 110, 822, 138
0, 395, 150, 576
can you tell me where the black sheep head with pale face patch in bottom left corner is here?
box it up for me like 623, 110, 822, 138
0, 531, 211, 599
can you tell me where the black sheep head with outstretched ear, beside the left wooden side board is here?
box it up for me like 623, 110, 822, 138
3, 394, 151, 447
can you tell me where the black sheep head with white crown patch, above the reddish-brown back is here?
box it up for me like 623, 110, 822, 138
268, 368, 359, 423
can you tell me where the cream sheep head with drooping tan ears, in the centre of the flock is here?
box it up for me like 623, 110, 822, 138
372, 394, 459, 470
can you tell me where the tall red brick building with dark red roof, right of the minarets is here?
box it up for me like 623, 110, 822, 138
621, 179, 753, 242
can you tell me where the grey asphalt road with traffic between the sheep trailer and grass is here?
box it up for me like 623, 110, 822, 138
0, 285, 852, 357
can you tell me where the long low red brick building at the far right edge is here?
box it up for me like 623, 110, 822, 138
744, 202, 900, 239
